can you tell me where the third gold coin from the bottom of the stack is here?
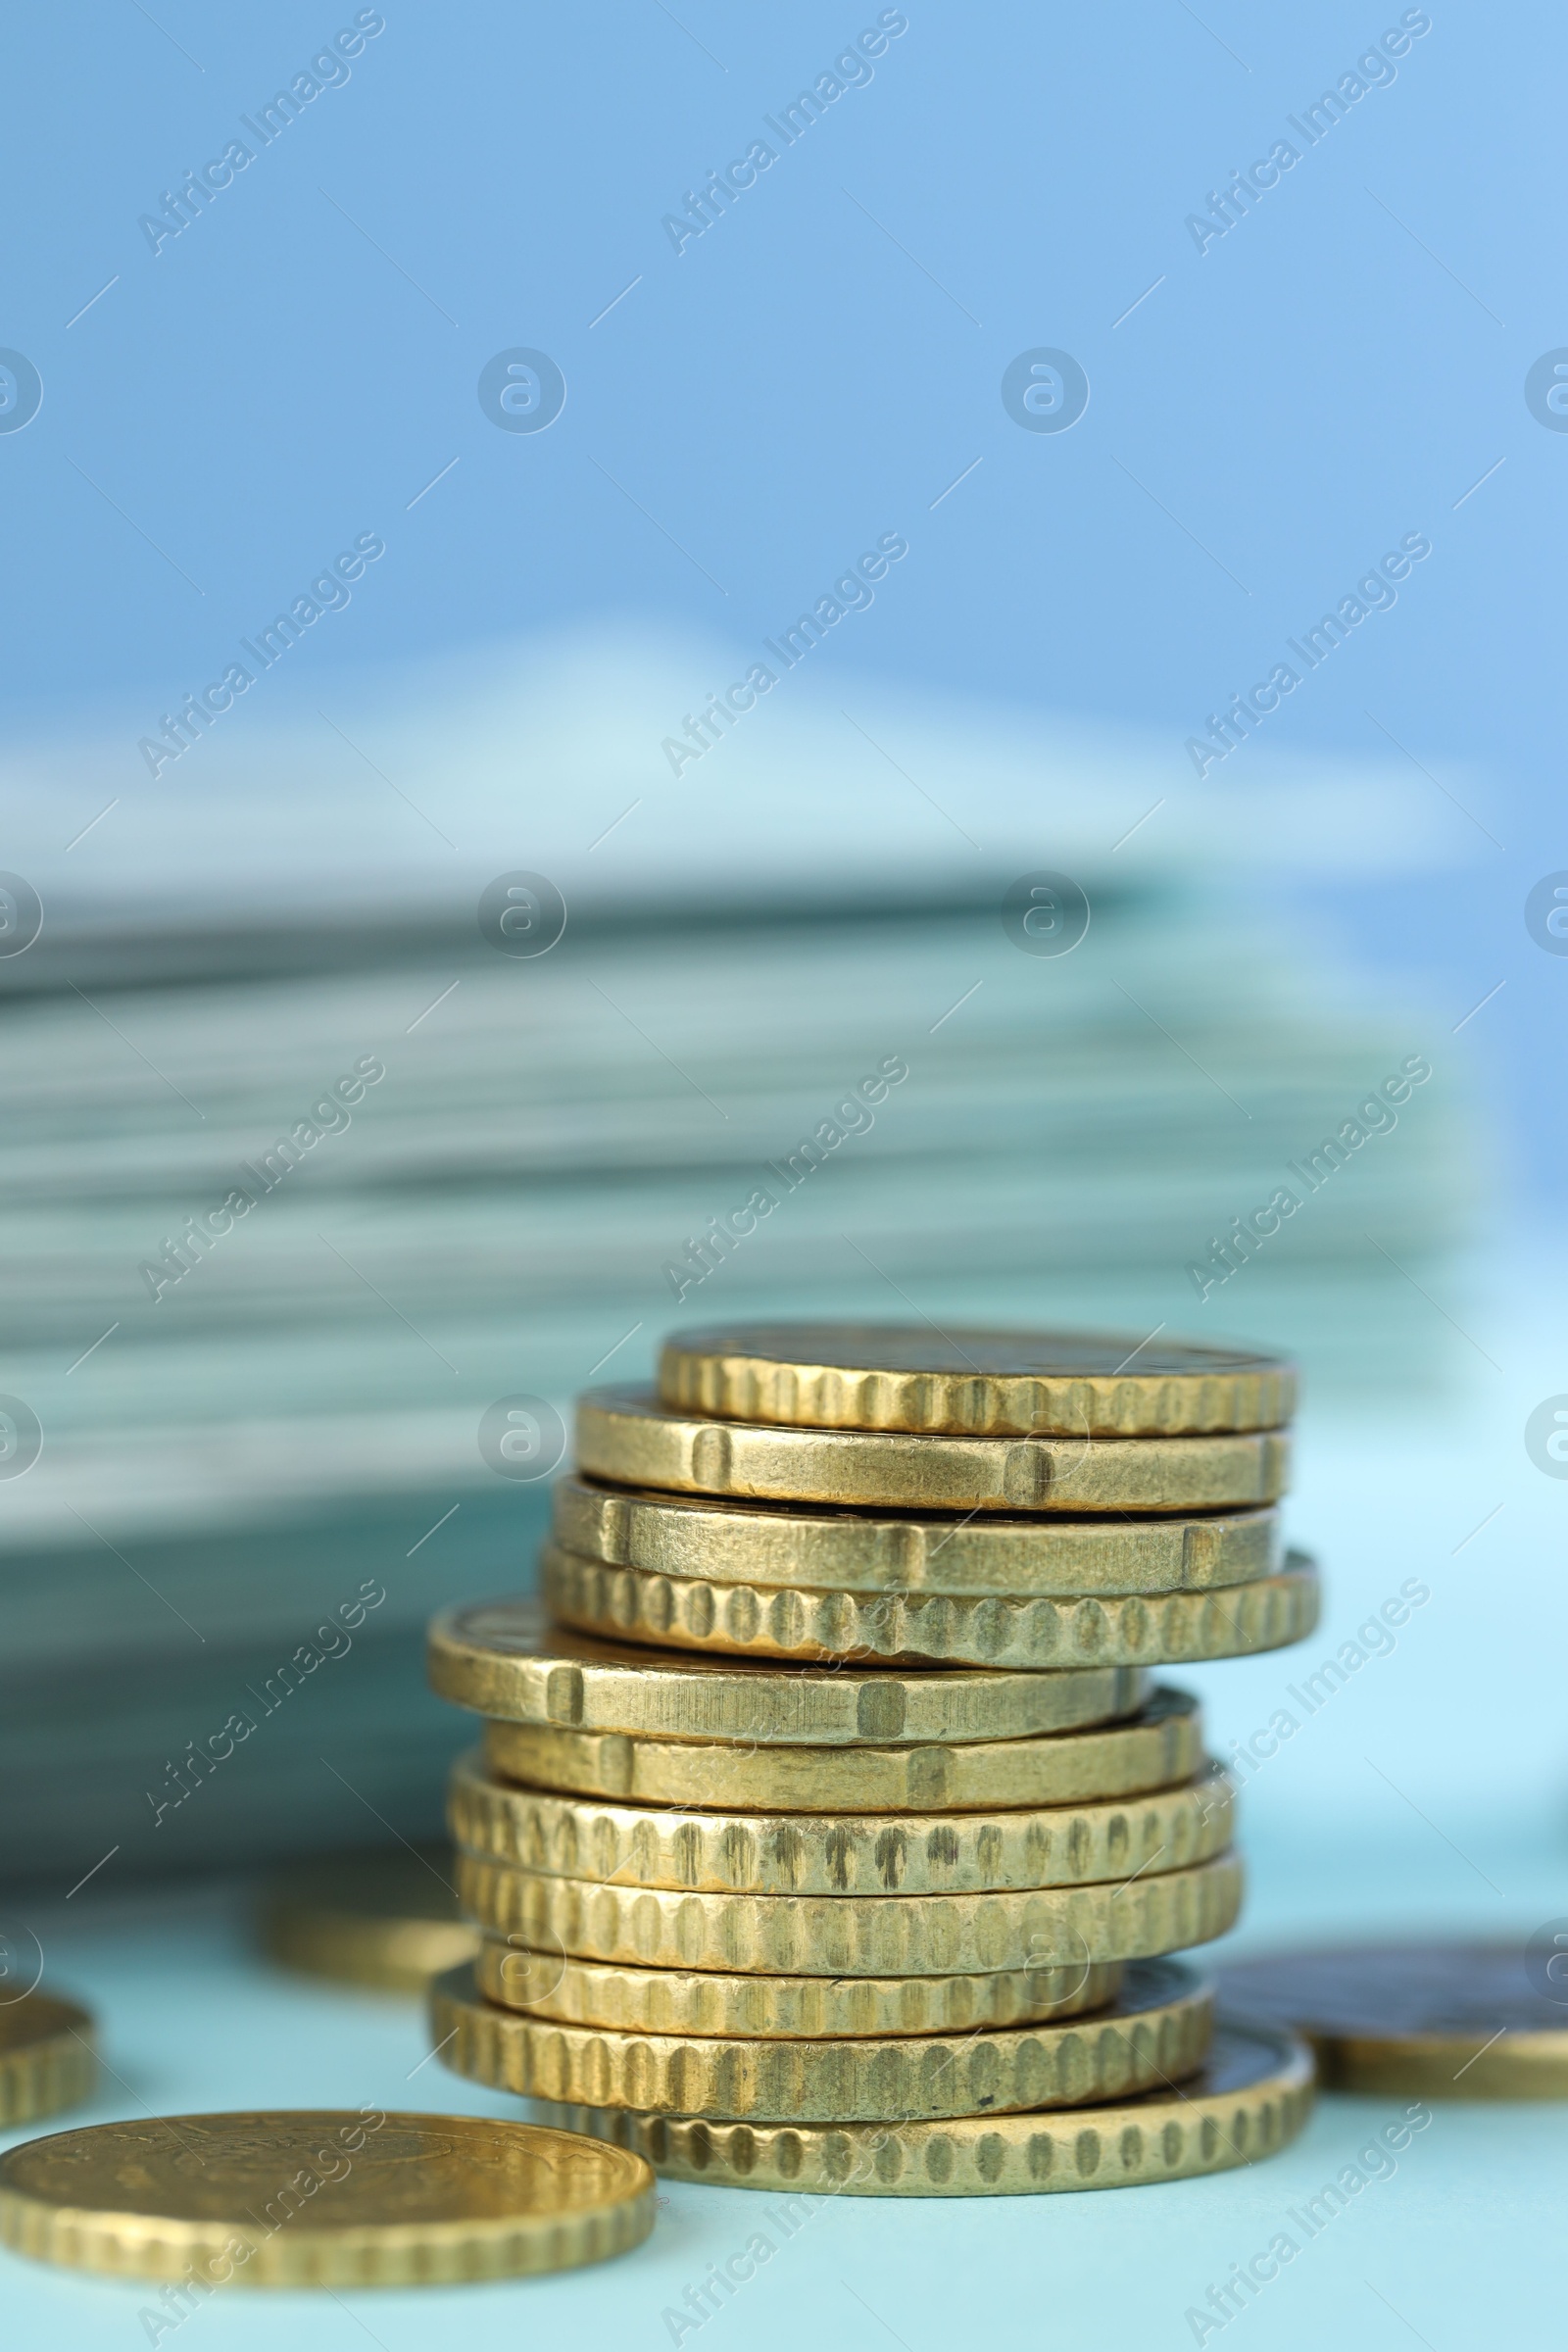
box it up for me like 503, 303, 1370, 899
475, 1936, 1124, 2041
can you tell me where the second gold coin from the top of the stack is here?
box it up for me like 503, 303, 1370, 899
576, 1388, 1291, 1512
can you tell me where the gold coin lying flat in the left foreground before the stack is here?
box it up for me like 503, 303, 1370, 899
0, 2107, 654, 2288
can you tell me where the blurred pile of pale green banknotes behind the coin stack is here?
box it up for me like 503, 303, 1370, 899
0, 625, 1469, 1888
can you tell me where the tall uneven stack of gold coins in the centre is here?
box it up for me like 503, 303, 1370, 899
430, 1324, 1319, 2194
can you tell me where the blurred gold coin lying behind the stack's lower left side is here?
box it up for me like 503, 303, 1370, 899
259, 1846, 479, 1992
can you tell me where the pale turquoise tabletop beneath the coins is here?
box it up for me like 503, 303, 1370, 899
0, 1853, 1568, 2352
